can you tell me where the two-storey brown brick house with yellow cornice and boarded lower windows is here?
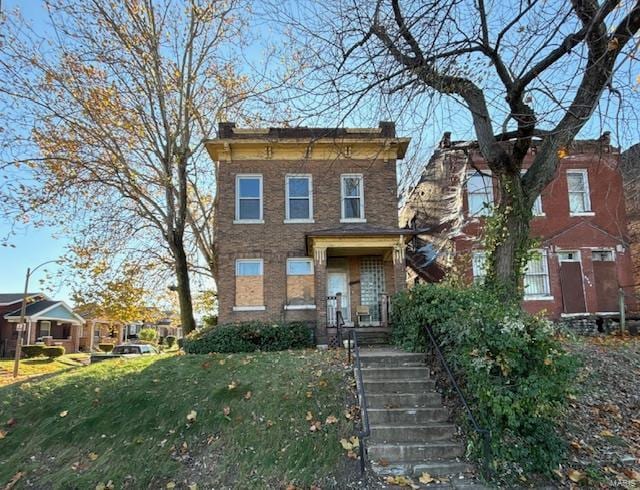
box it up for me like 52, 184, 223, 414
205, 123, 409, 344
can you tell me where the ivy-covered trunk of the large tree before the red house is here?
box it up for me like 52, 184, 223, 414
485, 168, 535, 301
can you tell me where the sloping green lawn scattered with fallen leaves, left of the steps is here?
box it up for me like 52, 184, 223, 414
0, 351, 354, 488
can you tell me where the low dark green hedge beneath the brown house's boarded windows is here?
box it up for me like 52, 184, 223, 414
183, 322, 313, 354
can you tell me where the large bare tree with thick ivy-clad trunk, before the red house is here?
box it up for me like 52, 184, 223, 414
264, 0, 640, 298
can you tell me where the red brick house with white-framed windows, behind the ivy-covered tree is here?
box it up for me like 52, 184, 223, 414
400, 134, 635, 319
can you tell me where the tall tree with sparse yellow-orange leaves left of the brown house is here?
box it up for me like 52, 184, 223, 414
0, 0, 252, 332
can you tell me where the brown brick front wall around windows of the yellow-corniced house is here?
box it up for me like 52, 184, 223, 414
216, 159, 398, 323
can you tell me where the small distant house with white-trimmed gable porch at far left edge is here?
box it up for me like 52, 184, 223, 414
0, 293, 85, 357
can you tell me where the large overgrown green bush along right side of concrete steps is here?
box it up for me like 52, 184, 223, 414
392, 284, 577, 479
